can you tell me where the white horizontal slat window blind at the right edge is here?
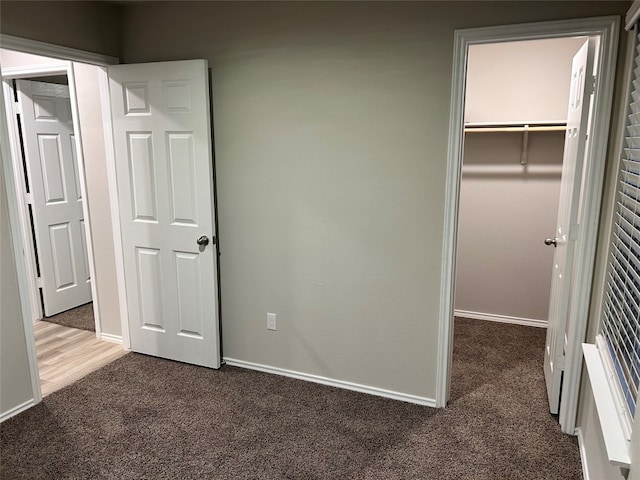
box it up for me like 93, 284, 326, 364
602, 26, 640, 417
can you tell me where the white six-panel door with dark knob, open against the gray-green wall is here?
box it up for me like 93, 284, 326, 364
108, 60, 220, 368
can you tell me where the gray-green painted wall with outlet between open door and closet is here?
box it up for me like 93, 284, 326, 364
115, 2, 626, 398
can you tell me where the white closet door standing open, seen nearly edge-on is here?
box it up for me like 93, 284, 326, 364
544, 39, 596, 414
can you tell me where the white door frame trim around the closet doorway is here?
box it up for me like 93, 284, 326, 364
436, 16, 620, 434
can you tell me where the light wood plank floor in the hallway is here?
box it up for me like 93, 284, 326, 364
33, 321, 127, 397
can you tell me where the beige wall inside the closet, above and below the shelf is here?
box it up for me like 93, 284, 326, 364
455, 38, 584, 325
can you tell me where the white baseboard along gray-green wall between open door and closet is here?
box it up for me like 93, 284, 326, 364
223, 357, 436, 408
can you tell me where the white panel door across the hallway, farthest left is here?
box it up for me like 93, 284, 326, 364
16, 80, 91, 316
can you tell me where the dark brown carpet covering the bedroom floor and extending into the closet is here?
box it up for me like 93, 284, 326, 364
0, 319, 581, 480
